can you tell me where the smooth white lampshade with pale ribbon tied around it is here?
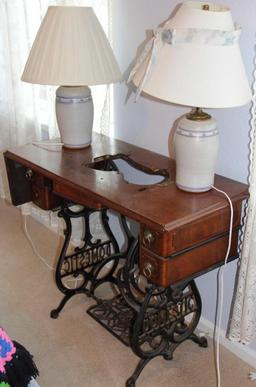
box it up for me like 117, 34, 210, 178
133, 1, 251, 108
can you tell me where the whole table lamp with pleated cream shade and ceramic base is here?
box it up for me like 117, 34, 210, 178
21, 6, 121, 148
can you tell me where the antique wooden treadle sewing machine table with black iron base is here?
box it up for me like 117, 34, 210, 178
4, 134, 248, 387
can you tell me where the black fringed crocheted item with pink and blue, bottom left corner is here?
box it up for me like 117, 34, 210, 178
0, 328, 39, 387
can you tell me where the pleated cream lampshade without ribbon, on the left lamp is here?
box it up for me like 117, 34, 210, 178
21, 6, 121, 86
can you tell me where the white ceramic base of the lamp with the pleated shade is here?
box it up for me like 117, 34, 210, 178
56, 86, 94, 149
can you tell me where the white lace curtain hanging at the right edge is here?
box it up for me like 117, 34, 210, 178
229, 49, 256, 344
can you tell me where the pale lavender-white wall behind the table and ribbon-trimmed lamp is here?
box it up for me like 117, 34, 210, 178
112, 0, 256, 349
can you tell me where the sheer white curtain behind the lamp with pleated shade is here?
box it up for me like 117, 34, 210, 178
0, 0, 111, 197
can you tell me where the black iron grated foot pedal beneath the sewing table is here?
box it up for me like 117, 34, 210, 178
87, 295, 136, 347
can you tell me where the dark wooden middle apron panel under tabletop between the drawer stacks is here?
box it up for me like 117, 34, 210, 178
53, 181, 102, 209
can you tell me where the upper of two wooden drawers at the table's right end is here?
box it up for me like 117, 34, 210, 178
140, 200, 241, 257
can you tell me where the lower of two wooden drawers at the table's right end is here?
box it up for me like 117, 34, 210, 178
139, 230, 238, 287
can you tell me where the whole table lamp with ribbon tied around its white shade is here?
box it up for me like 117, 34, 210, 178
128, 1, 251, 192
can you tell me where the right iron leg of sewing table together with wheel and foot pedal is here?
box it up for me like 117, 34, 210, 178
88, 240, 207, 387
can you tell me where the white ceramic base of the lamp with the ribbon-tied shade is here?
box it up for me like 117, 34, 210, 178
174, 113, 219, 192
